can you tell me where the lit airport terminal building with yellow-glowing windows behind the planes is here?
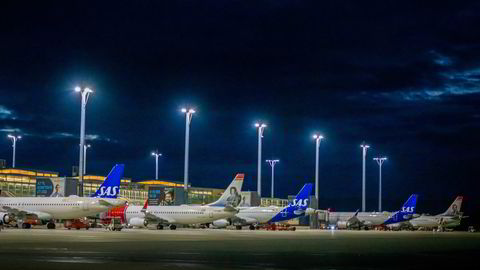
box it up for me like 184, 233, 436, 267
0, 163, 288, 207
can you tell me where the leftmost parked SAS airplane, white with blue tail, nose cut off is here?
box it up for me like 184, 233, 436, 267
0, 164, 125, 229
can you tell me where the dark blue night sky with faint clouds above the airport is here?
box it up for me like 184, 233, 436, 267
0, 0, 480, 218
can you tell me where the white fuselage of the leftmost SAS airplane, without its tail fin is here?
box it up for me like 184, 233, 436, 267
0, 197, 124, 220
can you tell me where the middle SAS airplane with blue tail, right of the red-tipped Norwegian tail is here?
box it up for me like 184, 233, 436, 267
212, 184, 315, 230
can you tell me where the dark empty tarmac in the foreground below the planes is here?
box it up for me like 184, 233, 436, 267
0, 228, 480, 270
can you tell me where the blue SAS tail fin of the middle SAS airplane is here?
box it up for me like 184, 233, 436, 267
268, 183, 313, 223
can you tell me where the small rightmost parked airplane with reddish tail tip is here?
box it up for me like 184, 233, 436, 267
408, 196, 465, 229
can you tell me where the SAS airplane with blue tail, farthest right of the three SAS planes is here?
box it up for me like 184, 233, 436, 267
328, 194, 418, 229
